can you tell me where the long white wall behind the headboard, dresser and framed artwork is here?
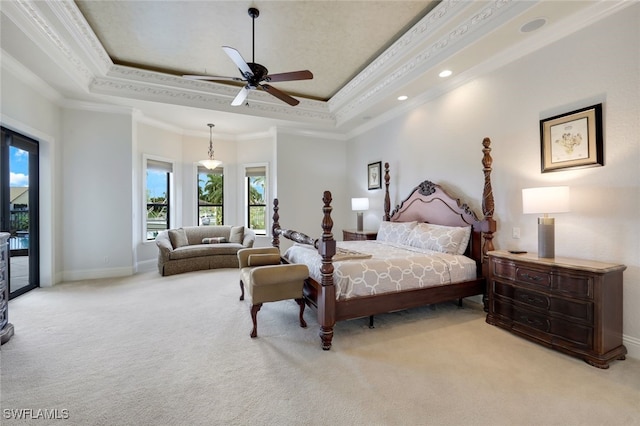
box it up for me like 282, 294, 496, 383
347, 4, 640, 358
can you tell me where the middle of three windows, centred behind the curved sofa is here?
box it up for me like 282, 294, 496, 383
198, 166, 224, 226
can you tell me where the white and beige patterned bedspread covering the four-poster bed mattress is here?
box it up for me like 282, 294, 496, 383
285, 240, 476, 300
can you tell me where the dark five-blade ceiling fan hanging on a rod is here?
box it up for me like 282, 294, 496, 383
183, 7, 313, 106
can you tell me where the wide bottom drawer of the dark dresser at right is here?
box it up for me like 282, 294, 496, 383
493, 300, 593, 348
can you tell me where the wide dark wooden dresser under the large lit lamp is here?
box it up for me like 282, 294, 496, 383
487, 251, 627, 368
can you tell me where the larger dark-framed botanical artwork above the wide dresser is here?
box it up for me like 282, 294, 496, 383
540, 104, 604, 173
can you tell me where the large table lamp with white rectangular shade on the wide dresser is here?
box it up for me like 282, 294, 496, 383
522, 186, 569, 258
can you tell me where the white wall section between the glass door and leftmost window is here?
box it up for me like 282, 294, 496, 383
60, 109, 135, 280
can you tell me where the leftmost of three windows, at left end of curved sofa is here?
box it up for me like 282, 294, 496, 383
144, 158, 173, 241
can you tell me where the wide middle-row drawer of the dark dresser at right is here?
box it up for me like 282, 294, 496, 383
492, 281, 593, 325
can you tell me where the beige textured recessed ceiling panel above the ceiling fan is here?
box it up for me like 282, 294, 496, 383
76, 0, 437, 101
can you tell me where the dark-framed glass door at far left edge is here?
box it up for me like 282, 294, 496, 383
0, 127, 40, 299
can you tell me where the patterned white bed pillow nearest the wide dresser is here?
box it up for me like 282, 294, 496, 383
407, 223, 471, 254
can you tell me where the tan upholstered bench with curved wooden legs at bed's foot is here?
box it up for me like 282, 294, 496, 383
238, 247, 309, 337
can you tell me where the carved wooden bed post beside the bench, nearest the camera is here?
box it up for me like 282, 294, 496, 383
318, 191, 336, 350
